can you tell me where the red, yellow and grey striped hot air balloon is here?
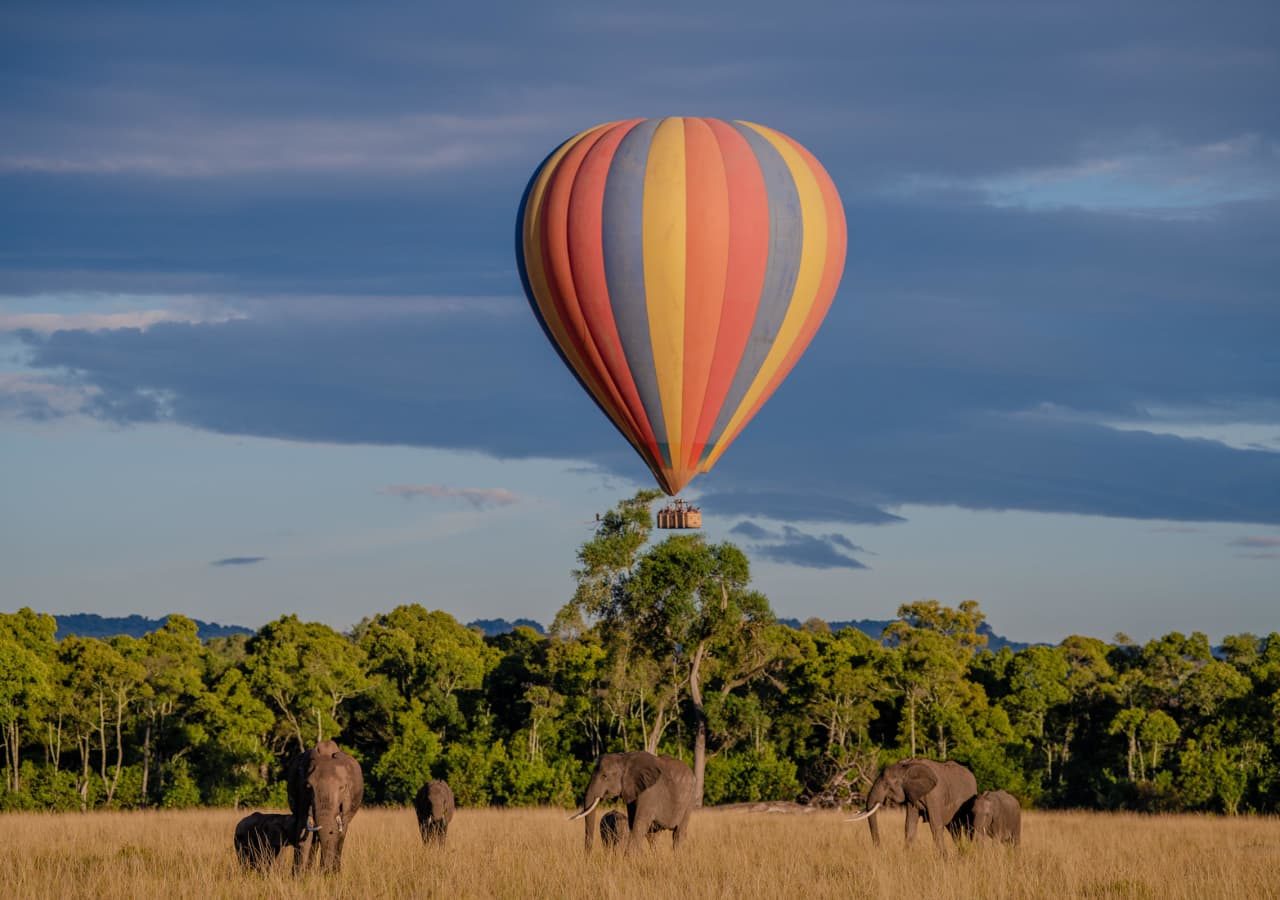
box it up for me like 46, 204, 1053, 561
516, 118, 846, 522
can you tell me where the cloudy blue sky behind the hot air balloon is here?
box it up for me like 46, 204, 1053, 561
0, 3, 1280, 640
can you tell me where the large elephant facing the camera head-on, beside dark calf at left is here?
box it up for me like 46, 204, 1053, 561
288, 741, 365, 872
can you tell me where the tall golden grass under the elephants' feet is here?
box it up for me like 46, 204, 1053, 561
0, 809, 1280, 900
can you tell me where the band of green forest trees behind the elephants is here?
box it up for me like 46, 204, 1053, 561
0, 492, 1280, 814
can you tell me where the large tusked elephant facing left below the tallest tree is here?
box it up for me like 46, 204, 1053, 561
570, 750, 694, 853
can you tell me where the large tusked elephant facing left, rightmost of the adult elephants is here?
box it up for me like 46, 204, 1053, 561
849, 759, 978, 853
